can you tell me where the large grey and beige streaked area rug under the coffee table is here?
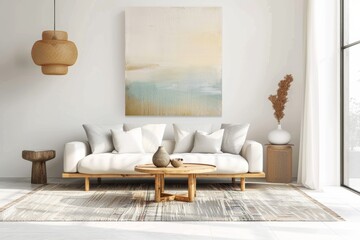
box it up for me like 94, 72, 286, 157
0, 182, 342, 221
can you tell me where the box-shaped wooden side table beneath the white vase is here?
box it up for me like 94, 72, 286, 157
266, 144, 293, 183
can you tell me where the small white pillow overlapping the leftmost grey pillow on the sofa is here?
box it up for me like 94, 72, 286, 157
111, 128, 144, 153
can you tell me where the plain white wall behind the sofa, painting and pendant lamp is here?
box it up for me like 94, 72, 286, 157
0, 0, 305, 177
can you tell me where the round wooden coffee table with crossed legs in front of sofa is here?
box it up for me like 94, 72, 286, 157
135, 163, 216, 202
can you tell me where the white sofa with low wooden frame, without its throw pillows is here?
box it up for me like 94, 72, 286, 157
62, 125, 265, 191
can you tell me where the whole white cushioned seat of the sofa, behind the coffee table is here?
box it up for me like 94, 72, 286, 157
78, 153, 249, 174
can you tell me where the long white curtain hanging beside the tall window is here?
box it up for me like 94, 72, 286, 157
298, 0, 340, 190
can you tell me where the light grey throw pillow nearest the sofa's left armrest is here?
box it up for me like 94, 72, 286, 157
83, 124, 123, 153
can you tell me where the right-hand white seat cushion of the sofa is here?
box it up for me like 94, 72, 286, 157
170, 153, 249, 174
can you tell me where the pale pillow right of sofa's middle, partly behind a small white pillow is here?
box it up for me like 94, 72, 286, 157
173, 124, 211, 153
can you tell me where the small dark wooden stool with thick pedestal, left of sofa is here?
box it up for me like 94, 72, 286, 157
22, 150, 55, 184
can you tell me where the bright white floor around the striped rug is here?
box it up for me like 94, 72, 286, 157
0, 178, 360, 240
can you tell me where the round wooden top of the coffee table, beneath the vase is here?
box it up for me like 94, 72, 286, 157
135, 163, 216, 175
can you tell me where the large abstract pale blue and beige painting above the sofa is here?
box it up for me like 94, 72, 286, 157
125, 7, 222, 116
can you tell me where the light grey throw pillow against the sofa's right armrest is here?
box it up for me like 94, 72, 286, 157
221, 124, 250, 154
